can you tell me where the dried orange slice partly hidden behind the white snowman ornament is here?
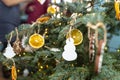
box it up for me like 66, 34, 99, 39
66, 29, 83, 45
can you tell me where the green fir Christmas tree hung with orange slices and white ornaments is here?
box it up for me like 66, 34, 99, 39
0, 0, 120, 80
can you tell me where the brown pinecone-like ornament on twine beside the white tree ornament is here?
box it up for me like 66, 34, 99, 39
13, 28, 24, 55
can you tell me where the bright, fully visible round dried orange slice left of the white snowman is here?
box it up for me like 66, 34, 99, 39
29, 33, 45, 49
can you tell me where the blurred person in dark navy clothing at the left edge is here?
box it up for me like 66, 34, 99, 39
0, 0, 31, 51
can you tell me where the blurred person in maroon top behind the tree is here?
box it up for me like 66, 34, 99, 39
25, 0, 50, 24
